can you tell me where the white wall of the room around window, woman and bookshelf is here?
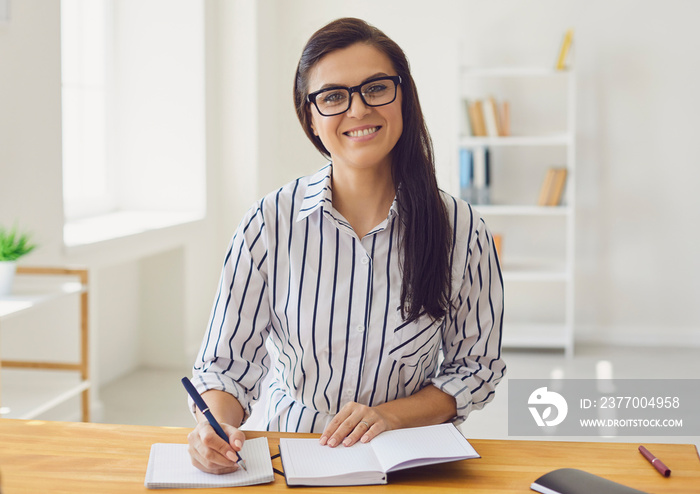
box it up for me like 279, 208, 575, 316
0, 0, 700, 420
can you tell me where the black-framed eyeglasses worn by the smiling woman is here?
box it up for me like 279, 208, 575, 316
306, 75, 401, 117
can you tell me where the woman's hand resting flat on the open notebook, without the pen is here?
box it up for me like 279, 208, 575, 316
320, 401, 394, 448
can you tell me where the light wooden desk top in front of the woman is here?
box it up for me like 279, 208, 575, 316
0, 419, 700, 494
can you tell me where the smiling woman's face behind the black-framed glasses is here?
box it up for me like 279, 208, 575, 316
308, 43, 403, 174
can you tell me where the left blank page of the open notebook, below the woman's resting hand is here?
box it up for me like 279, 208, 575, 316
280, 438, 381, 478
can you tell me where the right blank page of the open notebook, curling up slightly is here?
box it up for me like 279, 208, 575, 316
369, 424, 479, 472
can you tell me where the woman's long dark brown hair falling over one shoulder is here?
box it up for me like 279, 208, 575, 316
294, 18, 452, 321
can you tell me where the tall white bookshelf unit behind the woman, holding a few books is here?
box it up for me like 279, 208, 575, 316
455, 67, 576, 356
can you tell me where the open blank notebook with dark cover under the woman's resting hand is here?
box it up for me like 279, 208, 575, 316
280, 424, 480, 486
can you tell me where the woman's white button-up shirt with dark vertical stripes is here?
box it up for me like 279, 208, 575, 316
193, 164, 506, 432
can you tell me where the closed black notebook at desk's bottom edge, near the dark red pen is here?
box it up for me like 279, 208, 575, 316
530, 468, 647, 494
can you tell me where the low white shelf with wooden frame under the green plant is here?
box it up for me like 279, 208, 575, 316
0, 267, 91, 422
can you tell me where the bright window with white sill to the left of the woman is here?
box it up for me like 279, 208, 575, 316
61, 0, 206, 246
